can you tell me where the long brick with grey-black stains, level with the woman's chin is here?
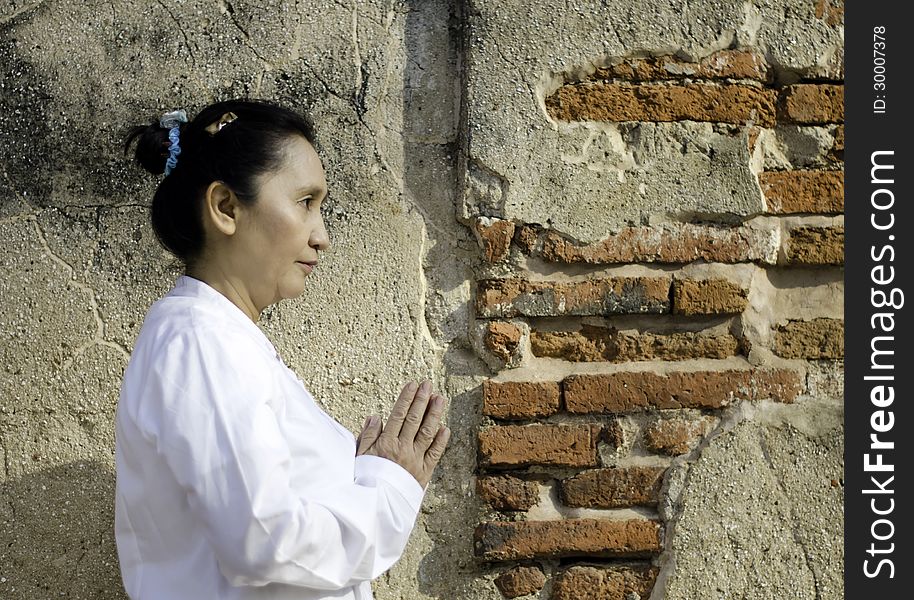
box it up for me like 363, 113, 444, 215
476, 277, 670, 318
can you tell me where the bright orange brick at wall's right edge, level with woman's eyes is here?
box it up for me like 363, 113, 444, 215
759, 171, 844, 214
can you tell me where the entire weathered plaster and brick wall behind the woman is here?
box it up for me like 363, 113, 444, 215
0, 0, 843, 600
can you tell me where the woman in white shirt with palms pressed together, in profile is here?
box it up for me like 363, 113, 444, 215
115, 101, 450, 600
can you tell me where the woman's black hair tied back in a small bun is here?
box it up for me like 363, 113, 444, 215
124, 100, 316, 265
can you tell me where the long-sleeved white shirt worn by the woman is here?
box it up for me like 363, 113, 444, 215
114, 275, 425, 600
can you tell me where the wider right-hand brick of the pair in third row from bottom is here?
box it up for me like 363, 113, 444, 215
561, 467, 666, 508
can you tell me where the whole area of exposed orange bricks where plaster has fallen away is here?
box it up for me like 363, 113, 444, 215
474, 50, 844, 600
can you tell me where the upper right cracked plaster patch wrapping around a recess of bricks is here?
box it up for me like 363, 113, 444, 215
462, 0, 843, 242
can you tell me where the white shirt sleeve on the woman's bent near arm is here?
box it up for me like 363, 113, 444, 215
143, 331, 425, 590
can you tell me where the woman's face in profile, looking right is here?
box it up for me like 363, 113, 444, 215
236, 135, 330, 310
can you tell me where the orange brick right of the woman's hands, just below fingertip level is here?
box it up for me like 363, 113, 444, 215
479, 425, 601, 467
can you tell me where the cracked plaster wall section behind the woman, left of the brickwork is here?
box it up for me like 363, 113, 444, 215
0, 0, 478, 599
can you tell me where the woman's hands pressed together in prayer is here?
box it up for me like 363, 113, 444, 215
356, 380, 451, 488
